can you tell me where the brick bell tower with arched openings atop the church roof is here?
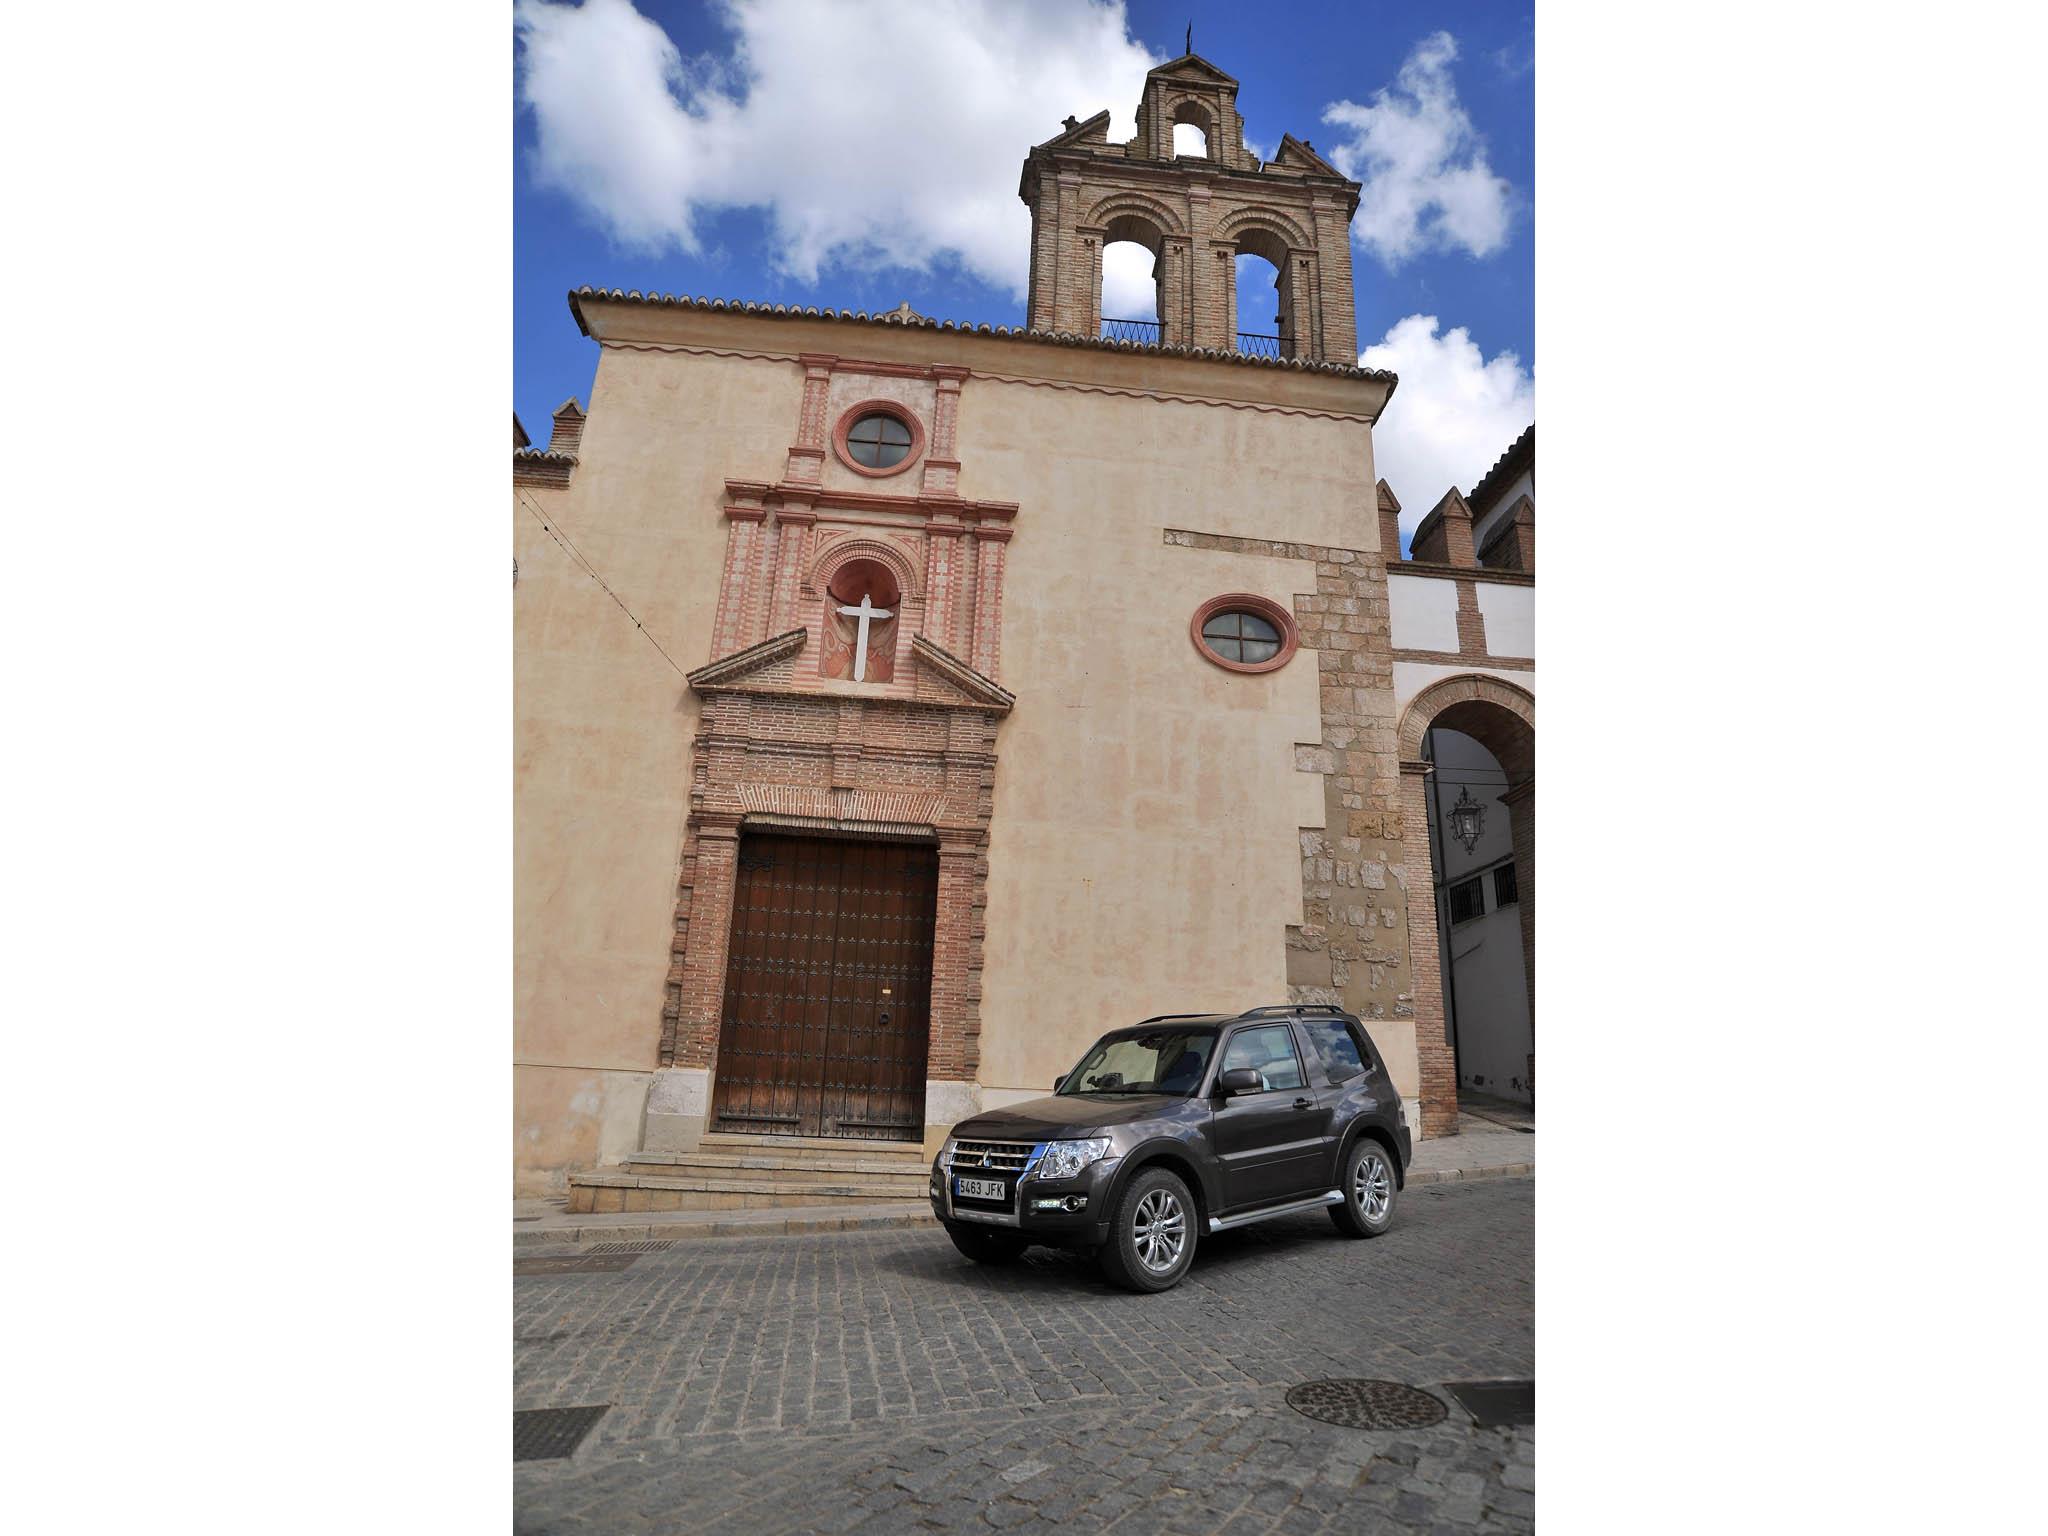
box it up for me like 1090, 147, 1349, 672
1018, 53, 1358, 365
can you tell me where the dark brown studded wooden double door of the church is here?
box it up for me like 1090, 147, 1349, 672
711, 834, 938, 1141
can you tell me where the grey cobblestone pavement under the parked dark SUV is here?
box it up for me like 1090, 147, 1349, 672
514, 1180, 1536, 1536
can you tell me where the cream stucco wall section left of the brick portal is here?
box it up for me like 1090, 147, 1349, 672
512, 350, 801, 1194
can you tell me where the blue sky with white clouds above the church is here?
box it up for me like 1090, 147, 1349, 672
514, 0, 1536, 526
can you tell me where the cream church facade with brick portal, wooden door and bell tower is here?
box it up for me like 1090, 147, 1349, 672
512, 55, 1523, 1210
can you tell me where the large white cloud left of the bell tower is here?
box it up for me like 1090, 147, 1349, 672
514, 0, 1159, 296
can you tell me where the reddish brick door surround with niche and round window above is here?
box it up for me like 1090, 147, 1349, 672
649, 354, 1018, 1141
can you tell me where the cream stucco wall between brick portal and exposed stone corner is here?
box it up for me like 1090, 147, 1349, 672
961, 379, 1376, 1100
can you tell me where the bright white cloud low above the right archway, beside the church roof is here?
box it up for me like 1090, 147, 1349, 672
1358, 315, 1536, 532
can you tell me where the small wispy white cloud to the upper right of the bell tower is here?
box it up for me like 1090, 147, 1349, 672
1323, 33, 1513, 270
